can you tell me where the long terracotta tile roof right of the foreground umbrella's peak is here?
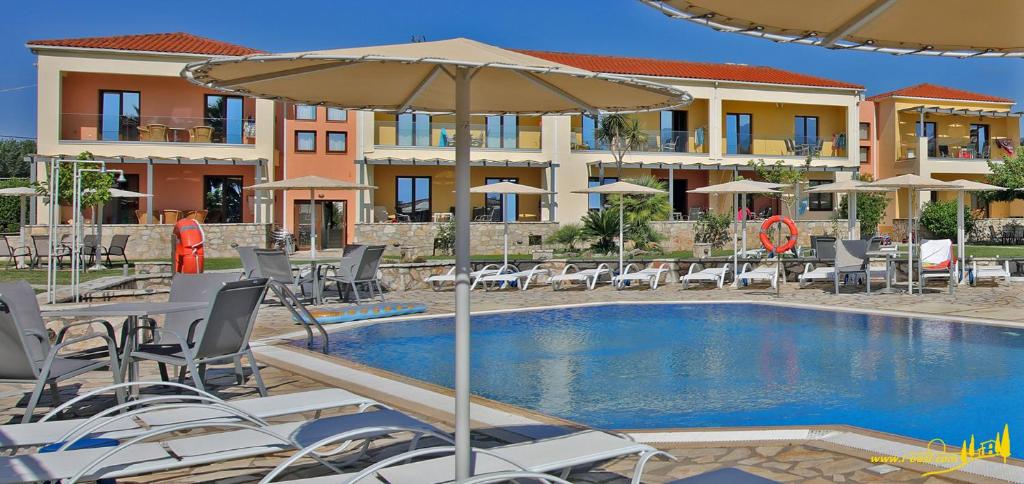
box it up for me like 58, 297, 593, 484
515, 49, 863, 89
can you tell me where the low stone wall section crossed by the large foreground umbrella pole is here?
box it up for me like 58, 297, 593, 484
355, 222, 558, 256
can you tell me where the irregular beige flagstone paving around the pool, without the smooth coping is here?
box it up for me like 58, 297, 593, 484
0, 283, 1024, 483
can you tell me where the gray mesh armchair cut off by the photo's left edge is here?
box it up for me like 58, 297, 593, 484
0, 280, 124, 424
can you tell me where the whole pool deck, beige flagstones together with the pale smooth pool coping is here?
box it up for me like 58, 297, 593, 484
0, 283, 1024, 483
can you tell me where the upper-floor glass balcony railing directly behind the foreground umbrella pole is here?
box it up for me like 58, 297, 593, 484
374, 121, 541, 149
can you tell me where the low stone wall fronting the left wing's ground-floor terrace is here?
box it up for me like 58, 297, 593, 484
25, 223, 270, 260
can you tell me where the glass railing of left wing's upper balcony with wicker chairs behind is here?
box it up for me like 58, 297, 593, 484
60, 113, 256, 144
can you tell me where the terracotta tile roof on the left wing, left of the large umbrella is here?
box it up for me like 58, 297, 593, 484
27, 32, 263, 55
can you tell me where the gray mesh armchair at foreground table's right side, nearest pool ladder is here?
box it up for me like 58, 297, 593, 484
122, 277, 268, 396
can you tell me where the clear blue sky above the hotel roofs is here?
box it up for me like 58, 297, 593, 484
0, 0, 1024, 136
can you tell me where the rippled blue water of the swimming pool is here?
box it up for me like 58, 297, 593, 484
299, 304, 1024, 442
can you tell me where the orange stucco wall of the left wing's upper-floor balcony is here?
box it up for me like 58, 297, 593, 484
60, 73, 256, 143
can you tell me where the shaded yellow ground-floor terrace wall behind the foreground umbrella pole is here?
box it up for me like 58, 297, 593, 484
373, 165, 544, 221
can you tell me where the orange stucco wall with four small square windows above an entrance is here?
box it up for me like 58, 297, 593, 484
275, 105, 358, 244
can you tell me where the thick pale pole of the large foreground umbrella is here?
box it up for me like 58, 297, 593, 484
455, 67, 471, 481
